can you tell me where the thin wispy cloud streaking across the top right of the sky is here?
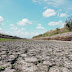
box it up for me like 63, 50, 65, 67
33, 0, 72, 10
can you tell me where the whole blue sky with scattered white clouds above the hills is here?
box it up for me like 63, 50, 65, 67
0, 0, 72, 38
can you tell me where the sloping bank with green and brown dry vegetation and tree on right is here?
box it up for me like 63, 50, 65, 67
33, 17, 72, 41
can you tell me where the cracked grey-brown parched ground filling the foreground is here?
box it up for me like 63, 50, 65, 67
0, 40, 72, 72
